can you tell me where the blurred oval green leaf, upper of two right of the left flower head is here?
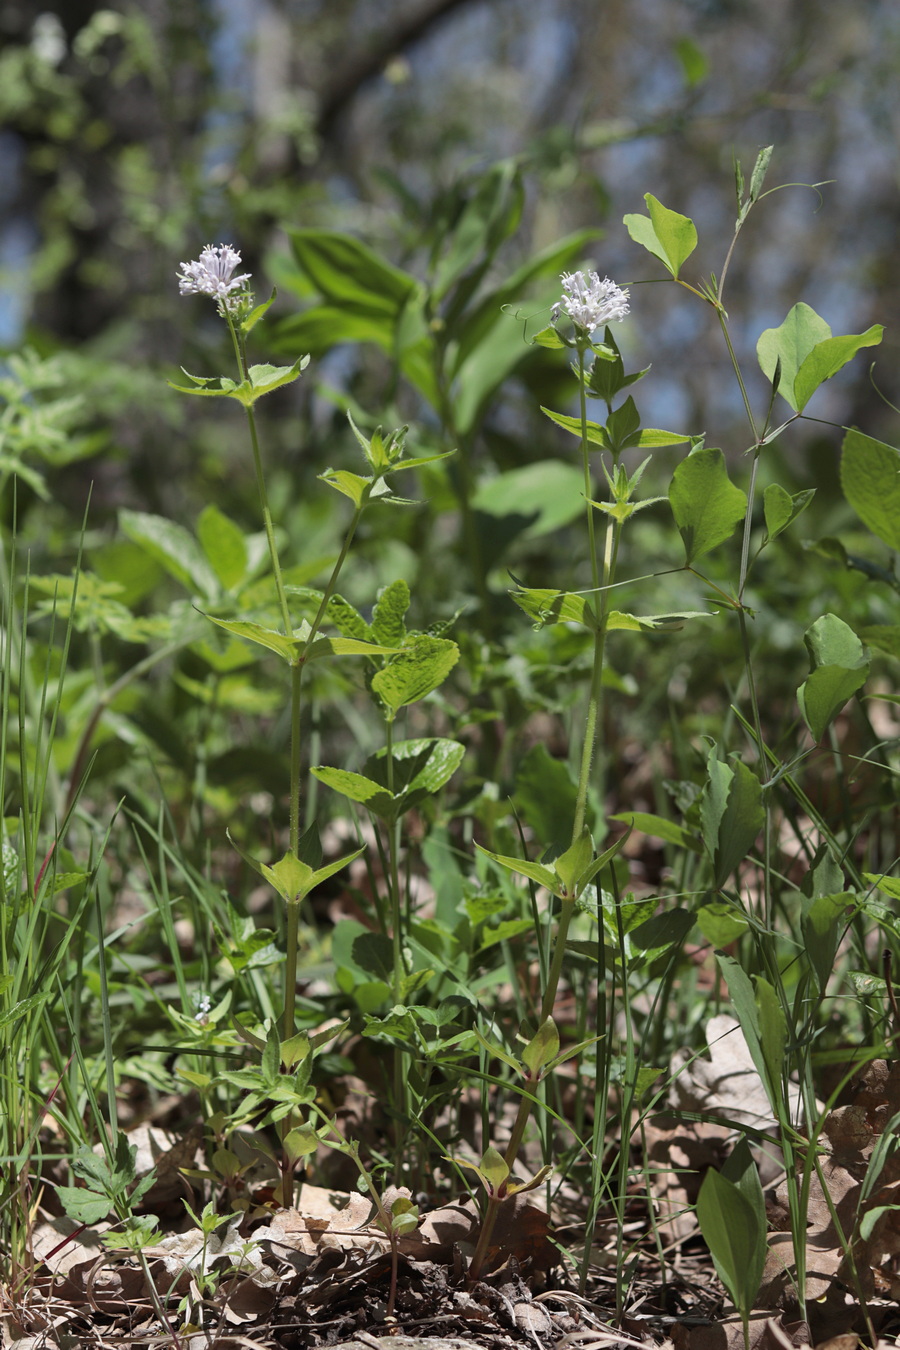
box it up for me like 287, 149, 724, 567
289, 230, 418, 316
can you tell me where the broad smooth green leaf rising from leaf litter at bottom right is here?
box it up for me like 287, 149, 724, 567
696, 1168, 768, 1319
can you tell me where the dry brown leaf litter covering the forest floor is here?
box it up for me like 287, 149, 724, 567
3, 1017, 900, 1350
